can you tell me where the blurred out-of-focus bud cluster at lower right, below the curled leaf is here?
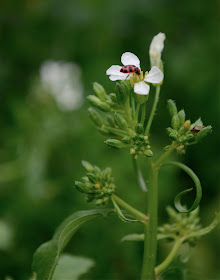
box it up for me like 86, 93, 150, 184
158, 206, 201, 244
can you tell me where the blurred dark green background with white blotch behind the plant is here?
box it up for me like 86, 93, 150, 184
0, 0, 220, 280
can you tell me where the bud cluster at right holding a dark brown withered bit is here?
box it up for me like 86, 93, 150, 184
167, 99, 212, 153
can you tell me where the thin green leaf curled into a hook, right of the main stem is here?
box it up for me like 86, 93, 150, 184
164, 161, 202, 213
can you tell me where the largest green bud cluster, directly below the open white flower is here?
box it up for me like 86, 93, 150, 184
88, 81, 153, 159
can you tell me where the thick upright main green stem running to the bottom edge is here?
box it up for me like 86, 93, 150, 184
141, 166, 158, 280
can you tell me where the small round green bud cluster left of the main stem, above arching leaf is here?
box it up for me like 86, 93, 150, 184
75, 161, 116, 205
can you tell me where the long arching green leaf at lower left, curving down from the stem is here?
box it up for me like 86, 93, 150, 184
32, 209, 114, 280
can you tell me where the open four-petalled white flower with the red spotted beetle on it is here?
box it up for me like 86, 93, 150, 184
106, 52, 163, 95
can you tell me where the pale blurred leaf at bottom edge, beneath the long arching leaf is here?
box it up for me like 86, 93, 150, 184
53, 254, 95, 280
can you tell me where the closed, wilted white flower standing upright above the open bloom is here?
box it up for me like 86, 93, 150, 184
149, 32, 166, 67
